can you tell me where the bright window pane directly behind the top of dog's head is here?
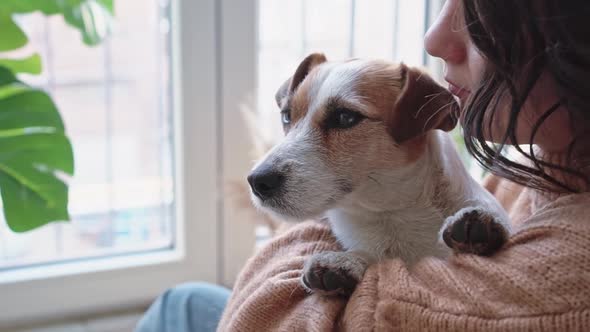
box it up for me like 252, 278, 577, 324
258, 0, 430, 135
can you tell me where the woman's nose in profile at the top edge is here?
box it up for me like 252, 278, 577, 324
424, 0, 469, 64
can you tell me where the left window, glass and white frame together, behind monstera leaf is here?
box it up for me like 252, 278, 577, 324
0, 0, 223, 329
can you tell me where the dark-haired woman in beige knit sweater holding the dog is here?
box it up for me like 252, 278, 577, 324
135, 0, 590, 331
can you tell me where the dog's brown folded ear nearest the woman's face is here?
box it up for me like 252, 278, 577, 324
385, 64, 459, 144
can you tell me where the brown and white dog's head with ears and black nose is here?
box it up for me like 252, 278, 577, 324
248, 53, 456, 220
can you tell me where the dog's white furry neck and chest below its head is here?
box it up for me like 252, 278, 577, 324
326, 131, 509, 262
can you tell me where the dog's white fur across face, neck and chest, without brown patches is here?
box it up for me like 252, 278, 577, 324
253, 55, 509, 294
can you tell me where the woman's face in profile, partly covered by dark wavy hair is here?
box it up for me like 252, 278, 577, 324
424, 0, 571, 151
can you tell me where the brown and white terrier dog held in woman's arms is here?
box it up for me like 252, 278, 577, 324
247, 53, 510, 295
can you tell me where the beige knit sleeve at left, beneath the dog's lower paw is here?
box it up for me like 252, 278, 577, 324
218, 222, 346, 331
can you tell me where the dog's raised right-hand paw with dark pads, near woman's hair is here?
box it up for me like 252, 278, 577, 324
441, 207, 510, 256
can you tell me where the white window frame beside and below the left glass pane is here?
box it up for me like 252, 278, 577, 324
0, 0, 258, 329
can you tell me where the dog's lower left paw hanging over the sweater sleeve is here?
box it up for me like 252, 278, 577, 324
301, 252, 368, 296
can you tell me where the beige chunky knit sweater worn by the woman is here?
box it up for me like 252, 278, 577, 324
219, 178, 590, 331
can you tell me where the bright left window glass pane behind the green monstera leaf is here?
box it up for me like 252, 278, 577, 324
0, 0, 174, 271
